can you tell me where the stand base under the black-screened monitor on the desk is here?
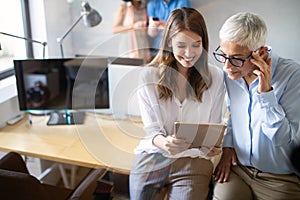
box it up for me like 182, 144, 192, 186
47, 110, 85, 125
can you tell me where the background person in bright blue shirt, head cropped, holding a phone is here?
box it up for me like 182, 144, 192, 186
147, 0, 191, 56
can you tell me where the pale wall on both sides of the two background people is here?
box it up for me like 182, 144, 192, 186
31, 0, 300, 62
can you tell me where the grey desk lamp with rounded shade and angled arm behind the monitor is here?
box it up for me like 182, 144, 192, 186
57, 2, 102, 58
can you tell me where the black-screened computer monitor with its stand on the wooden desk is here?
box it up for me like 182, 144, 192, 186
14, 57, 110, 125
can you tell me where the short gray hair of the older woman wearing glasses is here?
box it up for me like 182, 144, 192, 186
219, 12, 268, 51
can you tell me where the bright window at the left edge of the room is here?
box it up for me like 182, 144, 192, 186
0, 0, 27, 103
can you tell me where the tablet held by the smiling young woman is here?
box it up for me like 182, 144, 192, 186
174, 122, 226, 148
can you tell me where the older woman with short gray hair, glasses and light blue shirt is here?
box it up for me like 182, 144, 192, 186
214, 12, 300, 200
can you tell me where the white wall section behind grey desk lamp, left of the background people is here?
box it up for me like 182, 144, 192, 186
39, 0, 121, 57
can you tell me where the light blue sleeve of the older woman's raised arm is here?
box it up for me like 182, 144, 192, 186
258, 72, 300, 145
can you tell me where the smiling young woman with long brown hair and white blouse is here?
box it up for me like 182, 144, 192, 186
130, 7, 225, 199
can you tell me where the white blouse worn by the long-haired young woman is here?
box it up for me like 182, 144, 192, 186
135, 65, 225, 157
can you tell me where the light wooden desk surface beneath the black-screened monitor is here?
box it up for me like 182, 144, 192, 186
0, 113, 144, 173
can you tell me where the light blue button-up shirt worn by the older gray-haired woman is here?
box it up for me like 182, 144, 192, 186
223, 50, 300, 176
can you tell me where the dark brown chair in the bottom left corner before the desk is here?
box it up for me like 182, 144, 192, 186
0, 152, 106, 200
